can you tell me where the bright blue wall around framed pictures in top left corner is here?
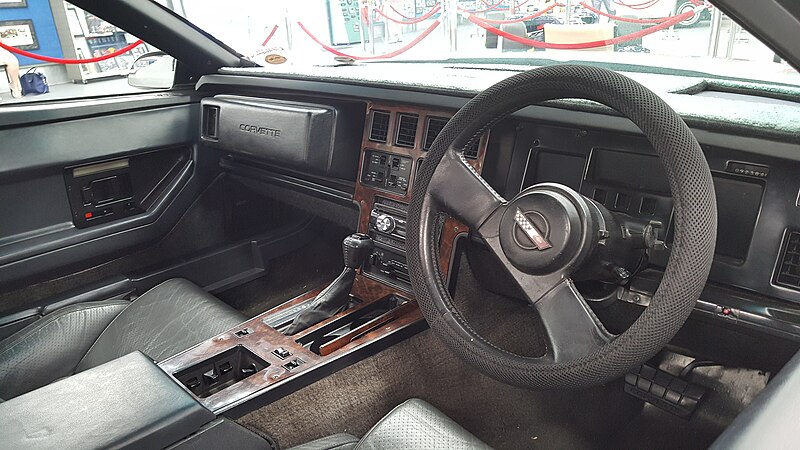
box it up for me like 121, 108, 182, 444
0, 0, 64, 66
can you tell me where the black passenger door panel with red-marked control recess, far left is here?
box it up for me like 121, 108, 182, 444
0, 95, 203, 291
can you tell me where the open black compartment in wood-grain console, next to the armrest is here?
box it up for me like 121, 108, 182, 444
174, 345, 269, 398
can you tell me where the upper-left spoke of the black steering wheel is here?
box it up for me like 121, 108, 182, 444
428, 146, 505, 229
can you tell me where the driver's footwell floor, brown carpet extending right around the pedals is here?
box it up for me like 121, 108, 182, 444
233, 253, 769, 449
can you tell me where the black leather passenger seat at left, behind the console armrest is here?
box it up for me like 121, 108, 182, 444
0, 278, 248, 400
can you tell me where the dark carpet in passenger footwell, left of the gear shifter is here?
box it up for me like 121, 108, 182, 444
216, 238, 344, 317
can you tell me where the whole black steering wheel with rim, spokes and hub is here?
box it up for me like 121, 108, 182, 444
407, 65, 717, 389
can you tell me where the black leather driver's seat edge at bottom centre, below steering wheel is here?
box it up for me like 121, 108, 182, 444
290, 398, 491, 450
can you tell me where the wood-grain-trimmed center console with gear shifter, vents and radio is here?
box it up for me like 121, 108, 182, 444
159, 104, 488, 414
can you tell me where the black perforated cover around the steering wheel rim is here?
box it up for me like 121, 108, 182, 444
407, 65, 717, 389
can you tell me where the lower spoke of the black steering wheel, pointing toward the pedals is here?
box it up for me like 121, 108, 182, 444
534, 278, 614, 363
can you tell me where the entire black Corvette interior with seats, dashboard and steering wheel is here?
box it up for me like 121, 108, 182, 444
0, 0, 800, 450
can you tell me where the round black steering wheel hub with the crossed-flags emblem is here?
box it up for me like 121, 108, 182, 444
500, 185, 590, 275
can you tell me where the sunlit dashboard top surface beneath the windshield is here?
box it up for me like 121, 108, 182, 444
212, 63, 800, 142
